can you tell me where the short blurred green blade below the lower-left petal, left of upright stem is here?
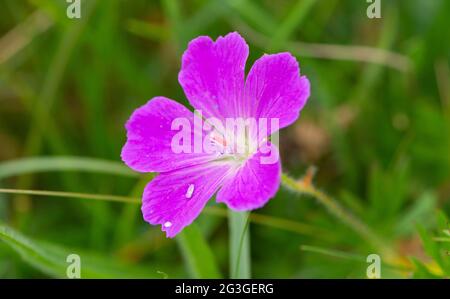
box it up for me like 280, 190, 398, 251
176, 224, 222, 278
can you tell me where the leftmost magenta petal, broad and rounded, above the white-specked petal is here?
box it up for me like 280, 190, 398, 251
121, 97, 214, 172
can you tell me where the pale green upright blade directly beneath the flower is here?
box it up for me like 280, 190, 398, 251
228, 210, 251, 278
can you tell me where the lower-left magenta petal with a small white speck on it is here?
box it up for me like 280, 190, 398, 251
142, 163, 231, 238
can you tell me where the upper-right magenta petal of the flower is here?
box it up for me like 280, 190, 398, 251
245, 53, 310, 133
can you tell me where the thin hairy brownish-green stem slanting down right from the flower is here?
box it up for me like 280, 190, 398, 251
281, 173, 397, 258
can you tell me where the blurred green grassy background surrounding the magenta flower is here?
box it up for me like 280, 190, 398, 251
0, 0, 450, 278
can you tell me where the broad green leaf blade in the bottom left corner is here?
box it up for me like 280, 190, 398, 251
0, 224, 160, 278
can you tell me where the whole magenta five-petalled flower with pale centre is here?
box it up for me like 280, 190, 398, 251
122, 32, 310, 237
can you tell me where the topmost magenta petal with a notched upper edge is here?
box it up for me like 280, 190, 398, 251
178, 32, 248, 120
